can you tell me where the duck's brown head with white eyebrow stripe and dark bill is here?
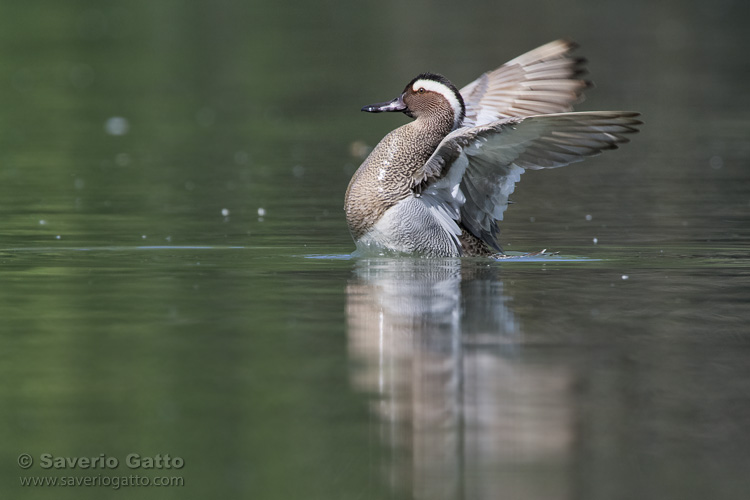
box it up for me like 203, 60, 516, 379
362, 73, 466, 129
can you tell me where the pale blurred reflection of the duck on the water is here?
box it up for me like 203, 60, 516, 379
347, 258, 572, 500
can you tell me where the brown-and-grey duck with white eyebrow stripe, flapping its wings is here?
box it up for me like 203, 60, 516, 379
344, 40, 642, 257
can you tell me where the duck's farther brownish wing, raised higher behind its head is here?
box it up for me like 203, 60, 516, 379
460, 40, 591, 127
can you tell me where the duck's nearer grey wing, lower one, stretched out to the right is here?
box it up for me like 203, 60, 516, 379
413, 111, 641, 251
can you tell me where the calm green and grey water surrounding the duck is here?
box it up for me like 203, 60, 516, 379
0, 1, 750, 499
